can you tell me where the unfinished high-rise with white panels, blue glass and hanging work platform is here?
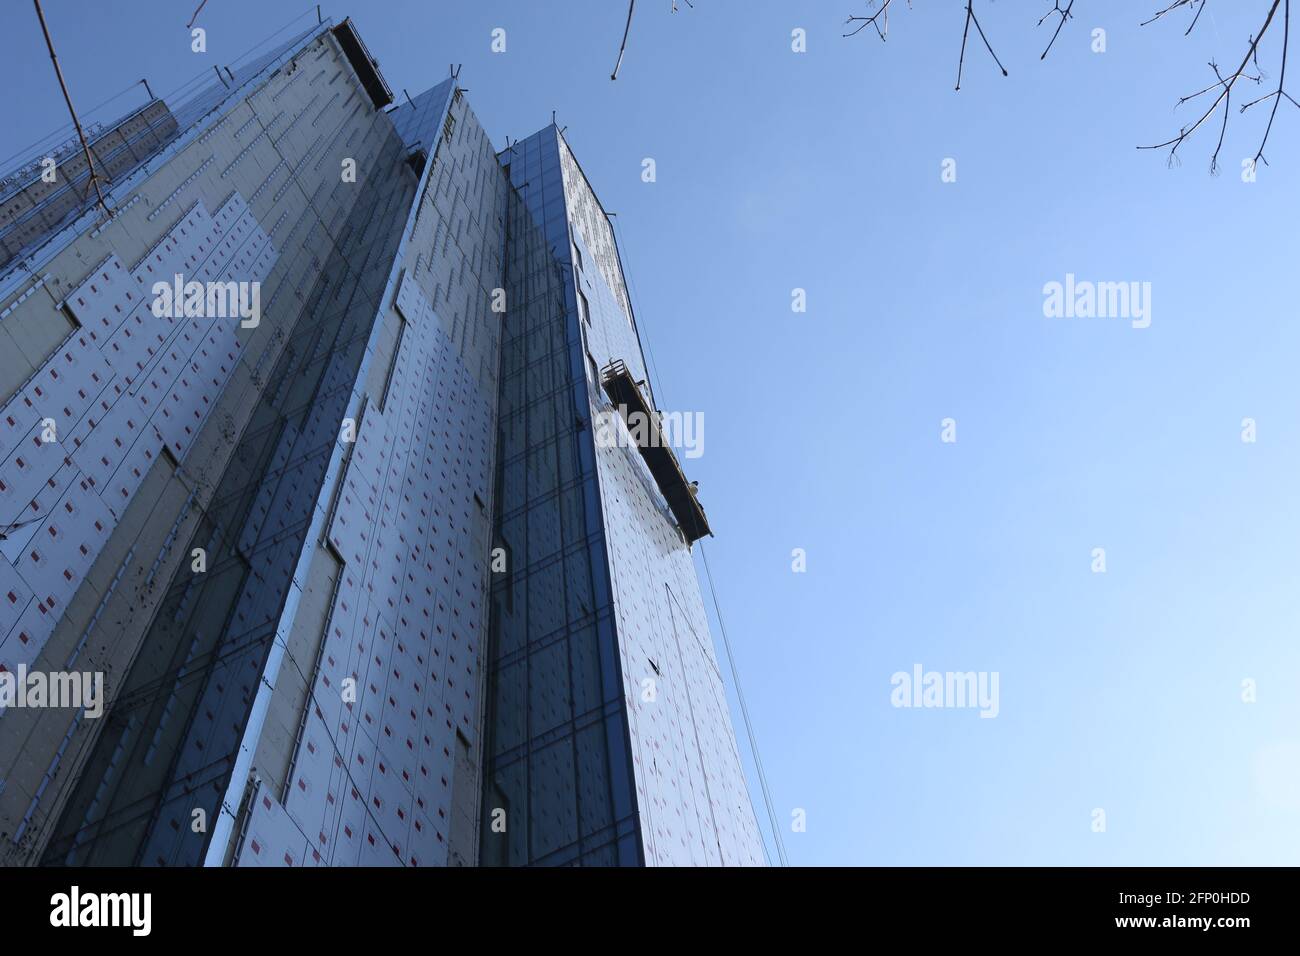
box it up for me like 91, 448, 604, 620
0, 13, 763, 866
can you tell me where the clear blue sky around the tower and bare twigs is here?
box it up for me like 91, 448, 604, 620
0, 0, 1300, 865
